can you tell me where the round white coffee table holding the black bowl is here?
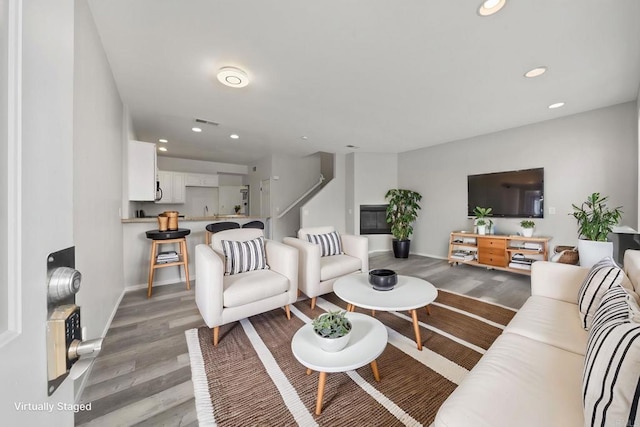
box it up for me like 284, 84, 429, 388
333, 273, 438, 350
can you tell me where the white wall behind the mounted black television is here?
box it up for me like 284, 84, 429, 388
398, 102, 638, 257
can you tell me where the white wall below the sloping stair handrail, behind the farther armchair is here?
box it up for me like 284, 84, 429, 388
300, 154, 352, 234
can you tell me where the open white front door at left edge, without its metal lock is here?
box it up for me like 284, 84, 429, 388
0, 0, 74, 426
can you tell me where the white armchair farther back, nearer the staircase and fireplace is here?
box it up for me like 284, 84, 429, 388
283, 226, 369, 309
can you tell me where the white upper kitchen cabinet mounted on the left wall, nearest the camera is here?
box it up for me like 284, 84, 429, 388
127, 141, 156, 202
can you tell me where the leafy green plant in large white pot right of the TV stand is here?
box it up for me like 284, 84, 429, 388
569, 193, 622, 267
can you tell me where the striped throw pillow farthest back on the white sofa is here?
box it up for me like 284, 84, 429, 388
578, 257, 625, 331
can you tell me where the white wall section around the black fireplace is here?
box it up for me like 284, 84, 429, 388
347, 153, 398, 252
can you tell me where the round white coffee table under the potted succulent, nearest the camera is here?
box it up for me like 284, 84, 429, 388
291, 313, 388, 415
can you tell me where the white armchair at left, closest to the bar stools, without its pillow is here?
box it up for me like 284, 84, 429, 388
196, 228, 298, 346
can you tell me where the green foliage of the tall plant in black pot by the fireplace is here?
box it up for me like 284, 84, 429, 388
384, 188, 422, 240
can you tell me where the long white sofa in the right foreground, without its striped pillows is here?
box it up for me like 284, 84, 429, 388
434, 251, 640, 427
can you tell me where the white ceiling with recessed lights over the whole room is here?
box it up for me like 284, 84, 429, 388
89, 0, 640, 164
